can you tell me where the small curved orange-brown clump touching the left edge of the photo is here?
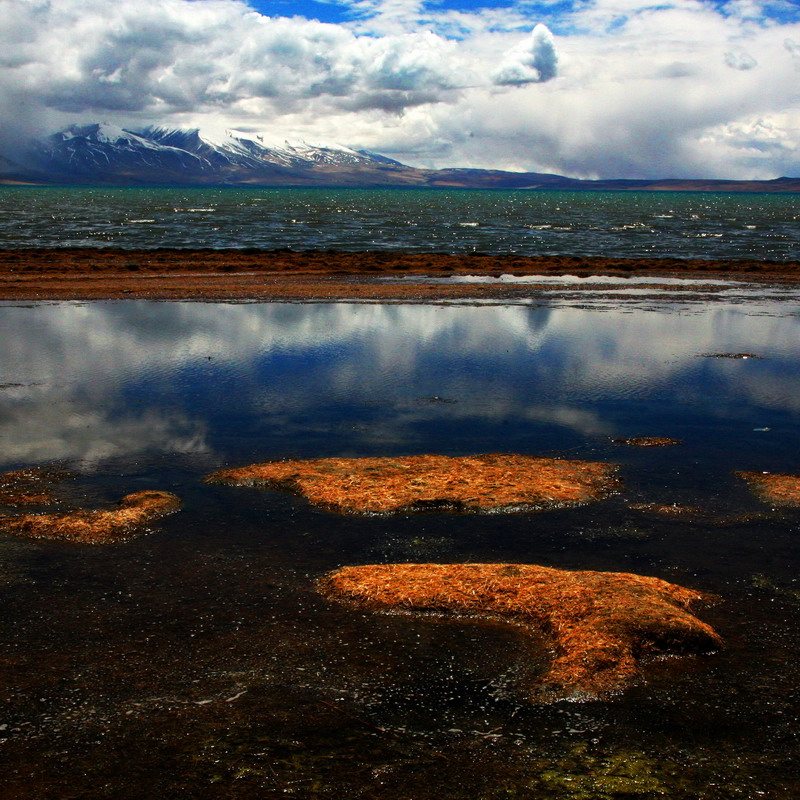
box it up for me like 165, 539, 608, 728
0, 491, 181, 544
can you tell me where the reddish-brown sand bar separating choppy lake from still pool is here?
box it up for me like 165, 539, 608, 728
0, 247, 800, 301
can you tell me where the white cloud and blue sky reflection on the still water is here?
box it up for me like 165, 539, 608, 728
0, 301, 800, 467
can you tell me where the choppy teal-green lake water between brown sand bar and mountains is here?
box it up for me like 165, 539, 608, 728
0, 187, 800, 261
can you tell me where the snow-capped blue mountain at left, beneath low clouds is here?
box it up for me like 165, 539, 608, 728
26, 123, 402, 184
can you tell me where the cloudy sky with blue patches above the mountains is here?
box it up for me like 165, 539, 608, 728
0, 0, 800, 179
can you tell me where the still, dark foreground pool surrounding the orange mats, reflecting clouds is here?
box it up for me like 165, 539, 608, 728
0, 297, 800, 800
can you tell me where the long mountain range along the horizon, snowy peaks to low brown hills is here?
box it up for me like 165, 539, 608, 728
0, 123, 800, 192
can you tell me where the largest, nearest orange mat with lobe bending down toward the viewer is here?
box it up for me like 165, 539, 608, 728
318, 564, 722, 700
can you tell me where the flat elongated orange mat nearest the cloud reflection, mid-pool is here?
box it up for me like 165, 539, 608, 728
206, 454, 617, 514
